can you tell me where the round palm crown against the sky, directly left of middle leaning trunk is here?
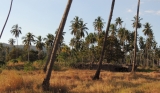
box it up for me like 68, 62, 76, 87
93, 16, 105, 33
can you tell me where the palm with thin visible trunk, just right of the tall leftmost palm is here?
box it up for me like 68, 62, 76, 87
22, 32, 35, 62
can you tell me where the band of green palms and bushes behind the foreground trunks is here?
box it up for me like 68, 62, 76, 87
0, 16, 160, 67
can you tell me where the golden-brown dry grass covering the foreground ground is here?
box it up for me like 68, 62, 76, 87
0, 69, 160, 93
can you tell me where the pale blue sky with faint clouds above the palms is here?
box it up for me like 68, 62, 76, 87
0, 0, 160, 46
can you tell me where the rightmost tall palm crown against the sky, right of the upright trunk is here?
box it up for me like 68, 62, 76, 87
143, 22, 153, 38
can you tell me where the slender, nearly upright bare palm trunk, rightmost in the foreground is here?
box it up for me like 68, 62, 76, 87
131, 0, 140, 72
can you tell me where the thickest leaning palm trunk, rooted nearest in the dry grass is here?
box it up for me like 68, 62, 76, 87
42, 0, 72, 91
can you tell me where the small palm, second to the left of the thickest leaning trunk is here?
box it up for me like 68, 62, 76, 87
35, 36, 45, 59
